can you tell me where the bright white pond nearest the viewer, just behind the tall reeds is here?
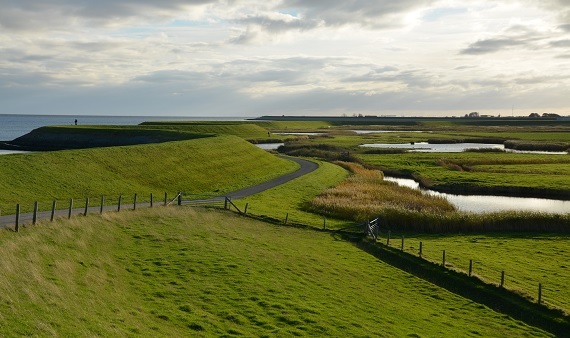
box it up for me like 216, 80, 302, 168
384, 177, 570, 214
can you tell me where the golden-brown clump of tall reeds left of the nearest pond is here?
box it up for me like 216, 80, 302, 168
308, 162, 455, 221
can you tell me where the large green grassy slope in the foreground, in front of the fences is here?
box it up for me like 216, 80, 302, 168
0, 208, 549, 337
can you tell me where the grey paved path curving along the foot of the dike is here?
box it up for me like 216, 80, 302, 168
0, 156, 319, 228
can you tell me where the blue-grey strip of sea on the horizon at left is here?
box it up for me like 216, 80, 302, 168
0, 114, 249, 141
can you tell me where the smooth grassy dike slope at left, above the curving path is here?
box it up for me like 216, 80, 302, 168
0, 136, 298, 215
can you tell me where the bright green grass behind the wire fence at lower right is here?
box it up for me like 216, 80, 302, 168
390, 233, 570, 313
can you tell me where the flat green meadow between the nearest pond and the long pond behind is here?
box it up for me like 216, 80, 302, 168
360, 153, 570, 195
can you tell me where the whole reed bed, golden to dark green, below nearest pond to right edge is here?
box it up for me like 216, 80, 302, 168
307, 162, 570, 233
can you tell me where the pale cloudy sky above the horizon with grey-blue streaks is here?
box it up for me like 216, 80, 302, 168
0, 0, 570, 117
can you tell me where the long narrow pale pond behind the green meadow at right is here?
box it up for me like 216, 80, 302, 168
361, 142, 568, 155
